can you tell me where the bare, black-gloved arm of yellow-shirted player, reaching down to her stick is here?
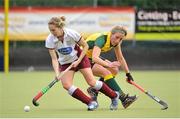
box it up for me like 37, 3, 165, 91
114, 42, 133, 80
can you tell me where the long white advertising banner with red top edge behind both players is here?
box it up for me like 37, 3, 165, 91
0, 7, 135, 40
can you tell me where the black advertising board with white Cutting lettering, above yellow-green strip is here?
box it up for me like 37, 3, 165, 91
136, 9, 180, 33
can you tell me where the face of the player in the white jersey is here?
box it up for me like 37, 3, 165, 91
49, 25, 63, 37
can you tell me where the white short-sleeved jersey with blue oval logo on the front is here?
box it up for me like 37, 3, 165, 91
45, 28, 81, 65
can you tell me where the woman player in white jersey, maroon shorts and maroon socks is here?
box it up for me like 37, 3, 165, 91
45, 17, 119, 110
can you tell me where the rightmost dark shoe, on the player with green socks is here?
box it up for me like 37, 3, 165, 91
122, 94, 137, 109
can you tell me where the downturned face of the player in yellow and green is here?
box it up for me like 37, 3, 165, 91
111, 32, 125, 46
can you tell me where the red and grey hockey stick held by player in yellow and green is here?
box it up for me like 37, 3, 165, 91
128, 80, 168, 110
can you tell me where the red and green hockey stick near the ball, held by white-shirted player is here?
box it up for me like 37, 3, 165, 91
32, 65, 72, 106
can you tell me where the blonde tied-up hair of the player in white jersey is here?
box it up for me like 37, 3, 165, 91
48, 16, 66, 28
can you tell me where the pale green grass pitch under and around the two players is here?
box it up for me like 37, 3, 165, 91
0, 71, 180, 118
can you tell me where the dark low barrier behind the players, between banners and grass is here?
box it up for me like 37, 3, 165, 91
0, 41, 180, 71
